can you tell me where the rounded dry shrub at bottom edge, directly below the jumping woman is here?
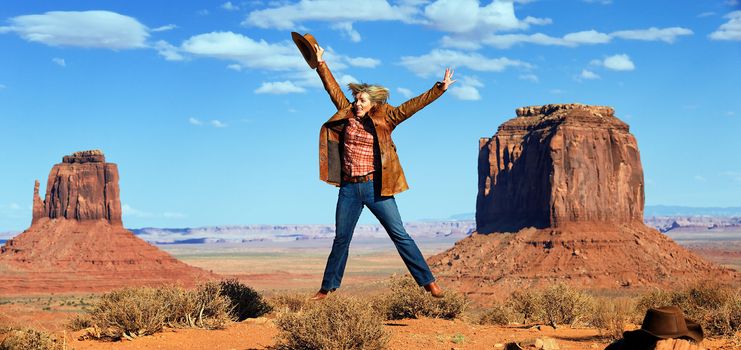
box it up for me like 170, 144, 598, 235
275, 295, 389, 350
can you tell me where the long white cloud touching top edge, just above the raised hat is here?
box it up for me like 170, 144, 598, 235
242, 0, 417, 30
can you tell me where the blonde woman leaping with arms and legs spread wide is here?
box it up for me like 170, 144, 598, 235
312, 44, 455, 300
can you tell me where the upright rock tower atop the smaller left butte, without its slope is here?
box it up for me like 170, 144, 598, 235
31, 150, 122, 226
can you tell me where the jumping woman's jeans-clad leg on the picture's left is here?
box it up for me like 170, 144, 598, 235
322, 183, 363, 294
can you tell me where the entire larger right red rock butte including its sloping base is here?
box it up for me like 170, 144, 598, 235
429, 104, 739, 297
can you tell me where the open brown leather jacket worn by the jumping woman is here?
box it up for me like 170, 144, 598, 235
317, 63, 445, 196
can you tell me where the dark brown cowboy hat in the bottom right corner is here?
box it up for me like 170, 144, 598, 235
623, 306, 703, 344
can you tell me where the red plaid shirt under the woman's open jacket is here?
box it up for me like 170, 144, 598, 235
342, 117, 376, 176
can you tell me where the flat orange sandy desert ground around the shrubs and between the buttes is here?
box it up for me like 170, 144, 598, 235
0, 233, 741, 350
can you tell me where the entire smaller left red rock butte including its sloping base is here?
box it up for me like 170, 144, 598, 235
0, 150, 216, 295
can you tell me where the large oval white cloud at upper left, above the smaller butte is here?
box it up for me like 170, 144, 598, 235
2, 11, 149, 50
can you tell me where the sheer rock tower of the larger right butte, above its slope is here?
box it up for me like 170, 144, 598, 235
476, 104, 644, 233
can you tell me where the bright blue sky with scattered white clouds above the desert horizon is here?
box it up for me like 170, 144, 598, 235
0, 0, 741, 231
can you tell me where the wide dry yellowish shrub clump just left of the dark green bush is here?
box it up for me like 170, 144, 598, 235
80, 282, 232, 340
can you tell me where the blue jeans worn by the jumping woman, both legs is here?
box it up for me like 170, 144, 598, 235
322, 180, 435, 291
